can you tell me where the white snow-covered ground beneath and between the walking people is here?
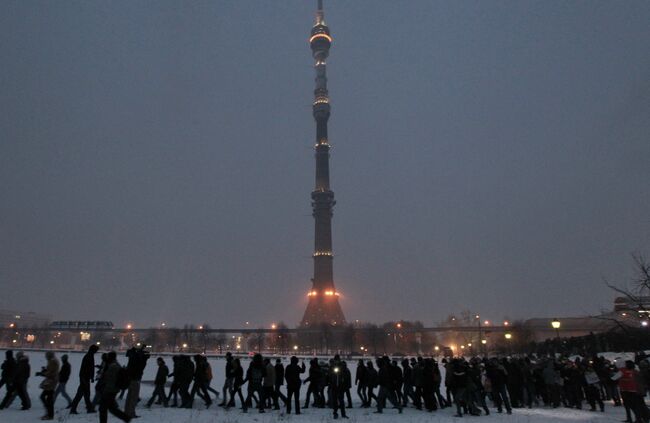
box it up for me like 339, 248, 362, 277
0, 351, 625, 423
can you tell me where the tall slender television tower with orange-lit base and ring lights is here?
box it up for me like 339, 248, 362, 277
301, 0, 345, 327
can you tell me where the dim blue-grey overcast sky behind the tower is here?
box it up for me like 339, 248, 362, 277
0, 0, 650, 327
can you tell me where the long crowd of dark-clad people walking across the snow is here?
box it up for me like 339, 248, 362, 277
0, 345, 650, 423
